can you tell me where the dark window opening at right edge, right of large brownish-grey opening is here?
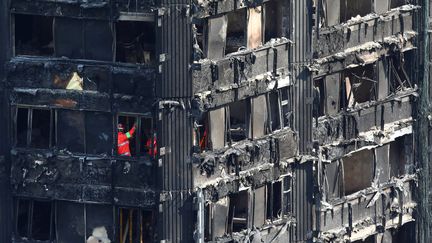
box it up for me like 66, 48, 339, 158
390, 135, 413, 177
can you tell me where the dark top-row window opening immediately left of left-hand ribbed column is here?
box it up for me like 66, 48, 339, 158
116, 21, 156, 64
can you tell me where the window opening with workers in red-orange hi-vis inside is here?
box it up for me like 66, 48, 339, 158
117, 116, 154, 157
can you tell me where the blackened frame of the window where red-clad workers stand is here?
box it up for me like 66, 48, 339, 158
113, 112, 154, 160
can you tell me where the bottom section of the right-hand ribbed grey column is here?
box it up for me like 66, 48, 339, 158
291, 162, 313, 242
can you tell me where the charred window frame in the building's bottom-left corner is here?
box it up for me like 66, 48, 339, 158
13, 198, 56, 242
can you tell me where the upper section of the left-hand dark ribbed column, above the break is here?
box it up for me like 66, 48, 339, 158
157, 5, 192, 98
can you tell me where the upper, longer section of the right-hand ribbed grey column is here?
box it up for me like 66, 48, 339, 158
290, 0, 312, 153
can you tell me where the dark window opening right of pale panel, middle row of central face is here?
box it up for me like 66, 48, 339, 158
229, 100, 250, 142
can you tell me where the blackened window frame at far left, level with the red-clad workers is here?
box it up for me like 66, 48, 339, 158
12, 105, 57, 149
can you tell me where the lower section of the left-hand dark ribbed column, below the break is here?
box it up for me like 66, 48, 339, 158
157, 105, 194, 242
